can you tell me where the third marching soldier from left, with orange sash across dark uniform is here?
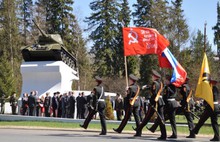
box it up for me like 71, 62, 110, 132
134, 70, 167, 140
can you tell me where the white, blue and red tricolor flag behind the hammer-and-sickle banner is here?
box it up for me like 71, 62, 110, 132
159, 48, 187, 87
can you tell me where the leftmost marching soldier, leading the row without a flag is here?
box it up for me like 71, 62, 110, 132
80, 76, 107, 135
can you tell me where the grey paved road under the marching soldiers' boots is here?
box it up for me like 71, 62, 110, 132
0, 128, 213, 142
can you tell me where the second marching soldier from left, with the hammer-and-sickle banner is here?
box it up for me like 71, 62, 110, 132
113, 74, 140, 133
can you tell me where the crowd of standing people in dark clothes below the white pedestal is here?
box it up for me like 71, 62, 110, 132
19, 91, 96, 119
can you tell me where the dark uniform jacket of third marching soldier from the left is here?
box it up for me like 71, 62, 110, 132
150, 80, 165, 106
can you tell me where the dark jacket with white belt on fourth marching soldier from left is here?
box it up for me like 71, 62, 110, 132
164, 84, 178, 108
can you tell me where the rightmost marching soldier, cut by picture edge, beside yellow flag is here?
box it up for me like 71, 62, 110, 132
193, 79, 220, 141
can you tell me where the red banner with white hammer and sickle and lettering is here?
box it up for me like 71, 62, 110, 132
123, 27, 169, 56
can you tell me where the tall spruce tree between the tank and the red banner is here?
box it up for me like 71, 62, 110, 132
85, 0, 121, 76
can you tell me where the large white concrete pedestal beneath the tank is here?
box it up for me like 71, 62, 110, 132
21, 61, 79, 97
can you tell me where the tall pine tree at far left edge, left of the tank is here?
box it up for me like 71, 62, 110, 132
0, 0, 21, 95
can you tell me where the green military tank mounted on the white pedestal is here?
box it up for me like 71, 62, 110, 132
21, 21, 77, 70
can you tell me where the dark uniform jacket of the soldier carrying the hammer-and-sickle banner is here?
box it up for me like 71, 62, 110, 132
127, 83, 140, 107
